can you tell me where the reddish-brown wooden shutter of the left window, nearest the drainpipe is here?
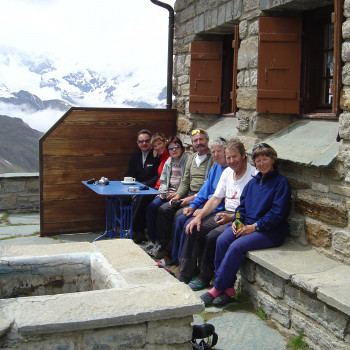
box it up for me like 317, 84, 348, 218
189, 41, 222, 114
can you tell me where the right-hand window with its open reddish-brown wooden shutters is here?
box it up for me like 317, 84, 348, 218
257, 0, 343, 118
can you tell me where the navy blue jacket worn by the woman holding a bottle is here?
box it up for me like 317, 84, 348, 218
236, 169, 291, 235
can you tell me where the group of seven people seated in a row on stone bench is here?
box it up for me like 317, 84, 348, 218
126, 129, 291, 306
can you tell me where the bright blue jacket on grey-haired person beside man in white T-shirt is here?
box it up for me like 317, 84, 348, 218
190, 163, 227, 213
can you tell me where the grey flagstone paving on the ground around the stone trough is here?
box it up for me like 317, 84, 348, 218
0, 213, 289, 350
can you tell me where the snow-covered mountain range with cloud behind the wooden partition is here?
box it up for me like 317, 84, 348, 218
0, 47, 166, 131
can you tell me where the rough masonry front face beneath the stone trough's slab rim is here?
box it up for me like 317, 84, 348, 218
2, 317, 193, 350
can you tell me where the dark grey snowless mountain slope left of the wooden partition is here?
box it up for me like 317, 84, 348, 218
0, 115, 43, 173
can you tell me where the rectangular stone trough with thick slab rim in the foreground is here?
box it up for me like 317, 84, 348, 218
0, 239, 204, 350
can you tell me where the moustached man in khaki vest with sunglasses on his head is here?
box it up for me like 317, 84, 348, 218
155, 129, 214, 261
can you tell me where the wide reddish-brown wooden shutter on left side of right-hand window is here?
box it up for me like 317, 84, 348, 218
256, 17, 302, 114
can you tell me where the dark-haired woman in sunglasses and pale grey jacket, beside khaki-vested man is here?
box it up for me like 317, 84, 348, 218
144, 136, 188, 255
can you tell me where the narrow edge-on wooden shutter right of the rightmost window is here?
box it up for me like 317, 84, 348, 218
332, 0, 344, 114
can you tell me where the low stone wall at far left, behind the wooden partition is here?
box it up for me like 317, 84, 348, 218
0, 173, 40, 212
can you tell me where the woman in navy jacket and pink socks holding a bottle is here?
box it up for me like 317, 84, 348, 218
201, 143, 291, 306
